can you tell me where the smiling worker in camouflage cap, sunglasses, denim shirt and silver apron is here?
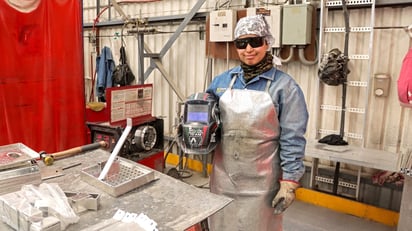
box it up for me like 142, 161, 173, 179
207, 15, 308, 231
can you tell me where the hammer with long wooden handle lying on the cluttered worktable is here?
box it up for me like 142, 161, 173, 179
39, 141, 107, 166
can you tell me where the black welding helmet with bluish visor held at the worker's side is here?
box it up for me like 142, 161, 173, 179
177, 92, 220, 154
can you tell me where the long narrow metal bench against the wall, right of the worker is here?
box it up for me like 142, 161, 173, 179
305, 141, 400, 199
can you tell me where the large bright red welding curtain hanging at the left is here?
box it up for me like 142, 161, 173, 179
0, 0, 86, 153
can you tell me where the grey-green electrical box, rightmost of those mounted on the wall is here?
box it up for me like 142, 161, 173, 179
282, 4, 313, 45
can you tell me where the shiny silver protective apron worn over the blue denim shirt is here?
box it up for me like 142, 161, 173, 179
209, 77, 282, 231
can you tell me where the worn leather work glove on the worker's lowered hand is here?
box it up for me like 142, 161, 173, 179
272, 180, 299, 215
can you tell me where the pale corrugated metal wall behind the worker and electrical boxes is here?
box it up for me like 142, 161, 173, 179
84, 0, 412, 162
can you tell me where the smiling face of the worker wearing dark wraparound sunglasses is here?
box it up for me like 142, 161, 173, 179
235, 34, 268, 66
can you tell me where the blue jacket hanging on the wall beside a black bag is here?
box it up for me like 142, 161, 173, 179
96, 46, 116, 102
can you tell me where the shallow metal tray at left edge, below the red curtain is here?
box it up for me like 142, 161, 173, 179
0, 143, 40, 170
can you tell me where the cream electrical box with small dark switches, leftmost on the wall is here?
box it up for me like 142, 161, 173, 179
209, 10, 237, 42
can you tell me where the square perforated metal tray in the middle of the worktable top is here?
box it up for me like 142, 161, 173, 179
80, 157, 156, 197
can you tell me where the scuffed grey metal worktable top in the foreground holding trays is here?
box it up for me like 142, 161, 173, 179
0, 150, 232, 231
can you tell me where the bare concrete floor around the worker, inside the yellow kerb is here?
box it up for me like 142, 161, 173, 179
170, 167, 397, 231
